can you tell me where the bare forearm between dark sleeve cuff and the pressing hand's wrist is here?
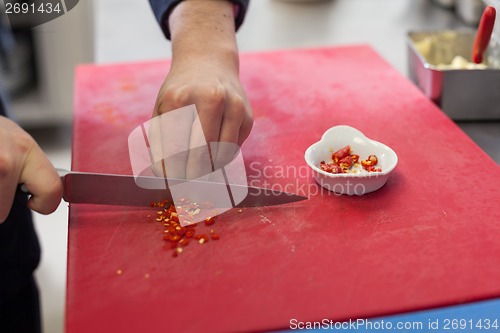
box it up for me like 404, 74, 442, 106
168, 0, 239, 73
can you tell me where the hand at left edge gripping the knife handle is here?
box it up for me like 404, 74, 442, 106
0, 116, 62, 223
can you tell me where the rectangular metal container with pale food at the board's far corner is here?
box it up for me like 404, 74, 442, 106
407, 30, 500, 120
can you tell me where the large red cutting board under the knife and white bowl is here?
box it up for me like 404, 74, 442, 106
66, 46, 500, 333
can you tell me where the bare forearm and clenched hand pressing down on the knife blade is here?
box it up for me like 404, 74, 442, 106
149, 0, 253, 179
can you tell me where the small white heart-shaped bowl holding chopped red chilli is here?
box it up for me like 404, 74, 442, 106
304, 125, 398, 195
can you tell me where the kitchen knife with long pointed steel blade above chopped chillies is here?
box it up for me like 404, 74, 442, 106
18, 170, 307, 208
